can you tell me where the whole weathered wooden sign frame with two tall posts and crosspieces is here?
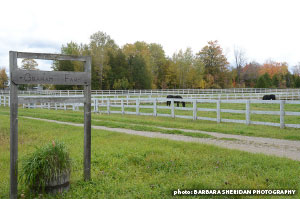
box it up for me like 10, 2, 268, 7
9, 51, 91, 198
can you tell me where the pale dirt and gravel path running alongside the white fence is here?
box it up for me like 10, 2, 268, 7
24, 117, 300, 161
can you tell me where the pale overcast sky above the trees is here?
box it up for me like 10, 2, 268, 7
0, 0, 300, 72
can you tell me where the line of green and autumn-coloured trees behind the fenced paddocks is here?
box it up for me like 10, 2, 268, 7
0, 31, 300, 90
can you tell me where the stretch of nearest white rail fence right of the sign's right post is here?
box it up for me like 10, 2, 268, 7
93, 98, 300, 128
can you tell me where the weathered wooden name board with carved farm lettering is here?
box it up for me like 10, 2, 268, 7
11, 70, 91, 85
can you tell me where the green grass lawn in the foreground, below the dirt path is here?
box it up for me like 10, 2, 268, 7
0, 109, 300, 198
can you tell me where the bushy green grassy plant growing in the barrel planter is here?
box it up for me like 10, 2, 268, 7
20, 141, 71, 191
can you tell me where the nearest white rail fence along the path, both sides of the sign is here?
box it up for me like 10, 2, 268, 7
0, 96, 300, 128
